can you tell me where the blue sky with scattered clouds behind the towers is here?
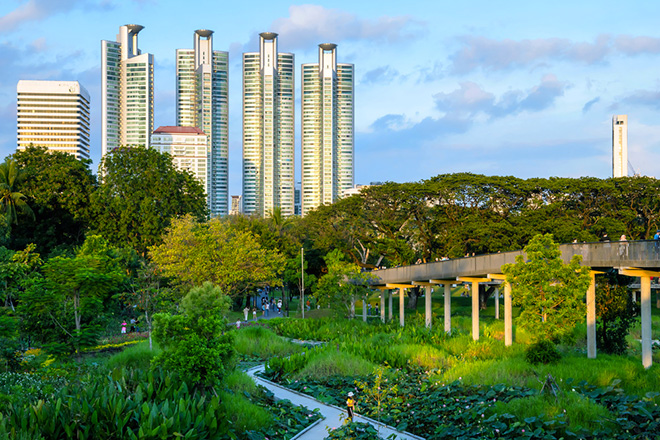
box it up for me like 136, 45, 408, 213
0, 0, 660, 195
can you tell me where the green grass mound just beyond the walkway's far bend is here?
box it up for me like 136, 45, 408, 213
234, 326, 304, 360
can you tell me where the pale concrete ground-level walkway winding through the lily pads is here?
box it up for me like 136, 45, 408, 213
246, 365, 424, 440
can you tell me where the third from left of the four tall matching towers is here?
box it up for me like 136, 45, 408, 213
243, 32, 294, 216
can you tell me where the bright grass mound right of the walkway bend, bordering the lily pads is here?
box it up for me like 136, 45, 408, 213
296, 350, 376, 379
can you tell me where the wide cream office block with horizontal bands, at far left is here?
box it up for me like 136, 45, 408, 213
16, 80, 90, 159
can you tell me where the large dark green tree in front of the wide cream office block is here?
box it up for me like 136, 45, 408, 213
12, 147, 97, 255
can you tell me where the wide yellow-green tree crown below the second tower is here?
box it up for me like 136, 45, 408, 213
149, 216, 284, 298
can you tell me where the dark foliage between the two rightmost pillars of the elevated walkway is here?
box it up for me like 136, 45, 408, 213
596, 279, 638, 354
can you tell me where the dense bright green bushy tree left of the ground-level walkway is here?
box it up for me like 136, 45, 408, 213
154, 282, 234, 387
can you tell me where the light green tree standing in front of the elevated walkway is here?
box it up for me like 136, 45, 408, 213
502, 234, 591, 340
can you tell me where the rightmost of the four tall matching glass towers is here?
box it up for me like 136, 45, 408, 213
302, 43, 354, 215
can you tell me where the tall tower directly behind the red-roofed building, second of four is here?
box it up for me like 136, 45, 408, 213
176, 29, 229, 216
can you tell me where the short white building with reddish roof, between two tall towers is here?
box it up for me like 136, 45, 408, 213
150, 126, 209, 189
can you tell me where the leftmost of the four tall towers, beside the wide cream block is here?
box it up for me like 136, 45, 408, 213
101, 24, 154, 155
